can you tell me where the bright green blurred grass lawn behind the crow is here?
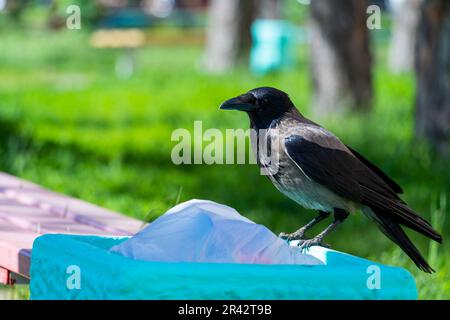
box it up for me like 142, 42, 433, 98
0, 31, 450, 299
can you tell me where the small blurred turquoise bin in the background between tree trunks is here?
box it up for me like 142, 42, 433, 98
250, 20, 297, 74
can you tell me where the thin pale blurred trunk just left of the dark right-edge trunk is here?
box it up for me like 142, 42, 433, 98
389, 0, 422, 73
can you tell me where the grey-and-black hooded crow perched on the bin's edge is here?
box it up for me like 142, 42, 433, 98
220, 87, 442, 273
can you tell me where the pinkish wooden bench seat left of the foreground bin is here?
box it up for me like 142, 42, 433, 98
0, 172, 143, 277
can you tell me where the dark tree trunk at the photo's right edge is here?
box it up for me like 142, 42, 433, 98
416, 0, 450, 155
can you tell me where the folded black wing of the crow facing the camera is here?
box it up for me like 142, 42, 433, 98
284, 135, 441, 241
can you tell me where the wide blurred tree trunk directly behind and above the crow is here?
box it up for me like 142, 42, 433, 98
310, 0, 372, 114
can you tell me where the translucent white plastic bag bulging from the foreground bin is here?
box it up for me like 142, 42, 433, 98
111, 200, 323, 265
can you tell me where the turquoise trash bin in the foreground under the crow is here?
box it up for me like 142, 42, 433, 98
30, 234, 417, 300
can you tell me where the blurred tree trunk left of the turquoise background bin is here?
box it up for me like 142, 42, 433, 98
203, 0, 255, 72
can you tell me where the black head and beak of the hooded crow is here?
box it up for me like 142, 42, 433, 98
220, 87, 295, 125
